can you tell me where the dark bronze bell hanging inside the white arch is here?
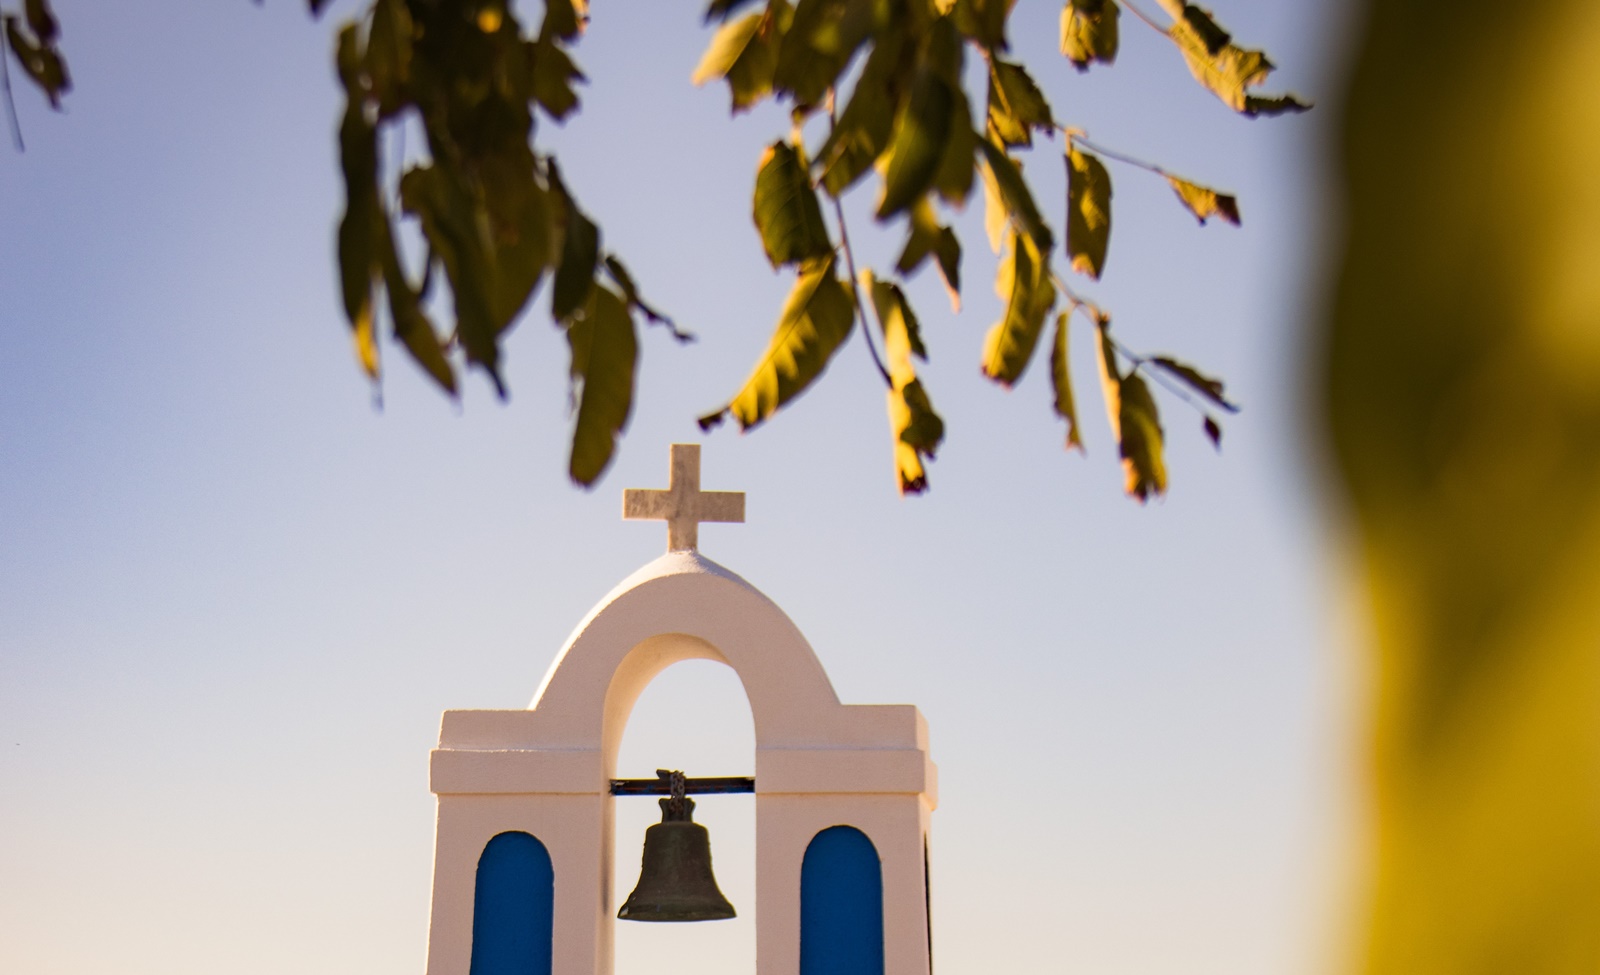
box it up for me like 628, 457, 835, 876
616, 772, 734, 921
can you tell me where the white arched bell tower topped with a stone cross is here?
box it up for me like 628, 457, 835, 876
427, 445, 938, 975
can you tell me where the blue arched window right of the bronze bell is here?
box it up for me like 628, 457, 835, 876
800, 826, 883, 975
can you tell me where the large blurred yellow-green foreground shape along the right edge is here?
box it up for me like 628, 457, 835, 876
1322, 0, 1600, 975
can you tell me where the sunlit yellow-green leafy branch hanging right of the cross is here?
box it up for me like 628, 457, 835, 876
694, 0, 1304, 500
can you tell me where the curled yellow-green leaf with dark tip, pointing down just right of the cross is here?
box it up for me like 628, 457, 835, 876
699, 256, 856, 429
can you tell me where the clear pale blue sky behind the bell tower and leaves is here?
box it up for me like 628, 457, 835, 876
0, 0, 1358, 975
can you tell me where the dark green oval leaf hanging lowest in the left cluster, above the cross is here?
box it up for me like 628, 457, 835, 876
566, 287, 638, 487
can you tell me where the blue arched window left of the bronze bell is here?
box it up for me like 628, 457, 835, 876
472, 833, 555, 975
